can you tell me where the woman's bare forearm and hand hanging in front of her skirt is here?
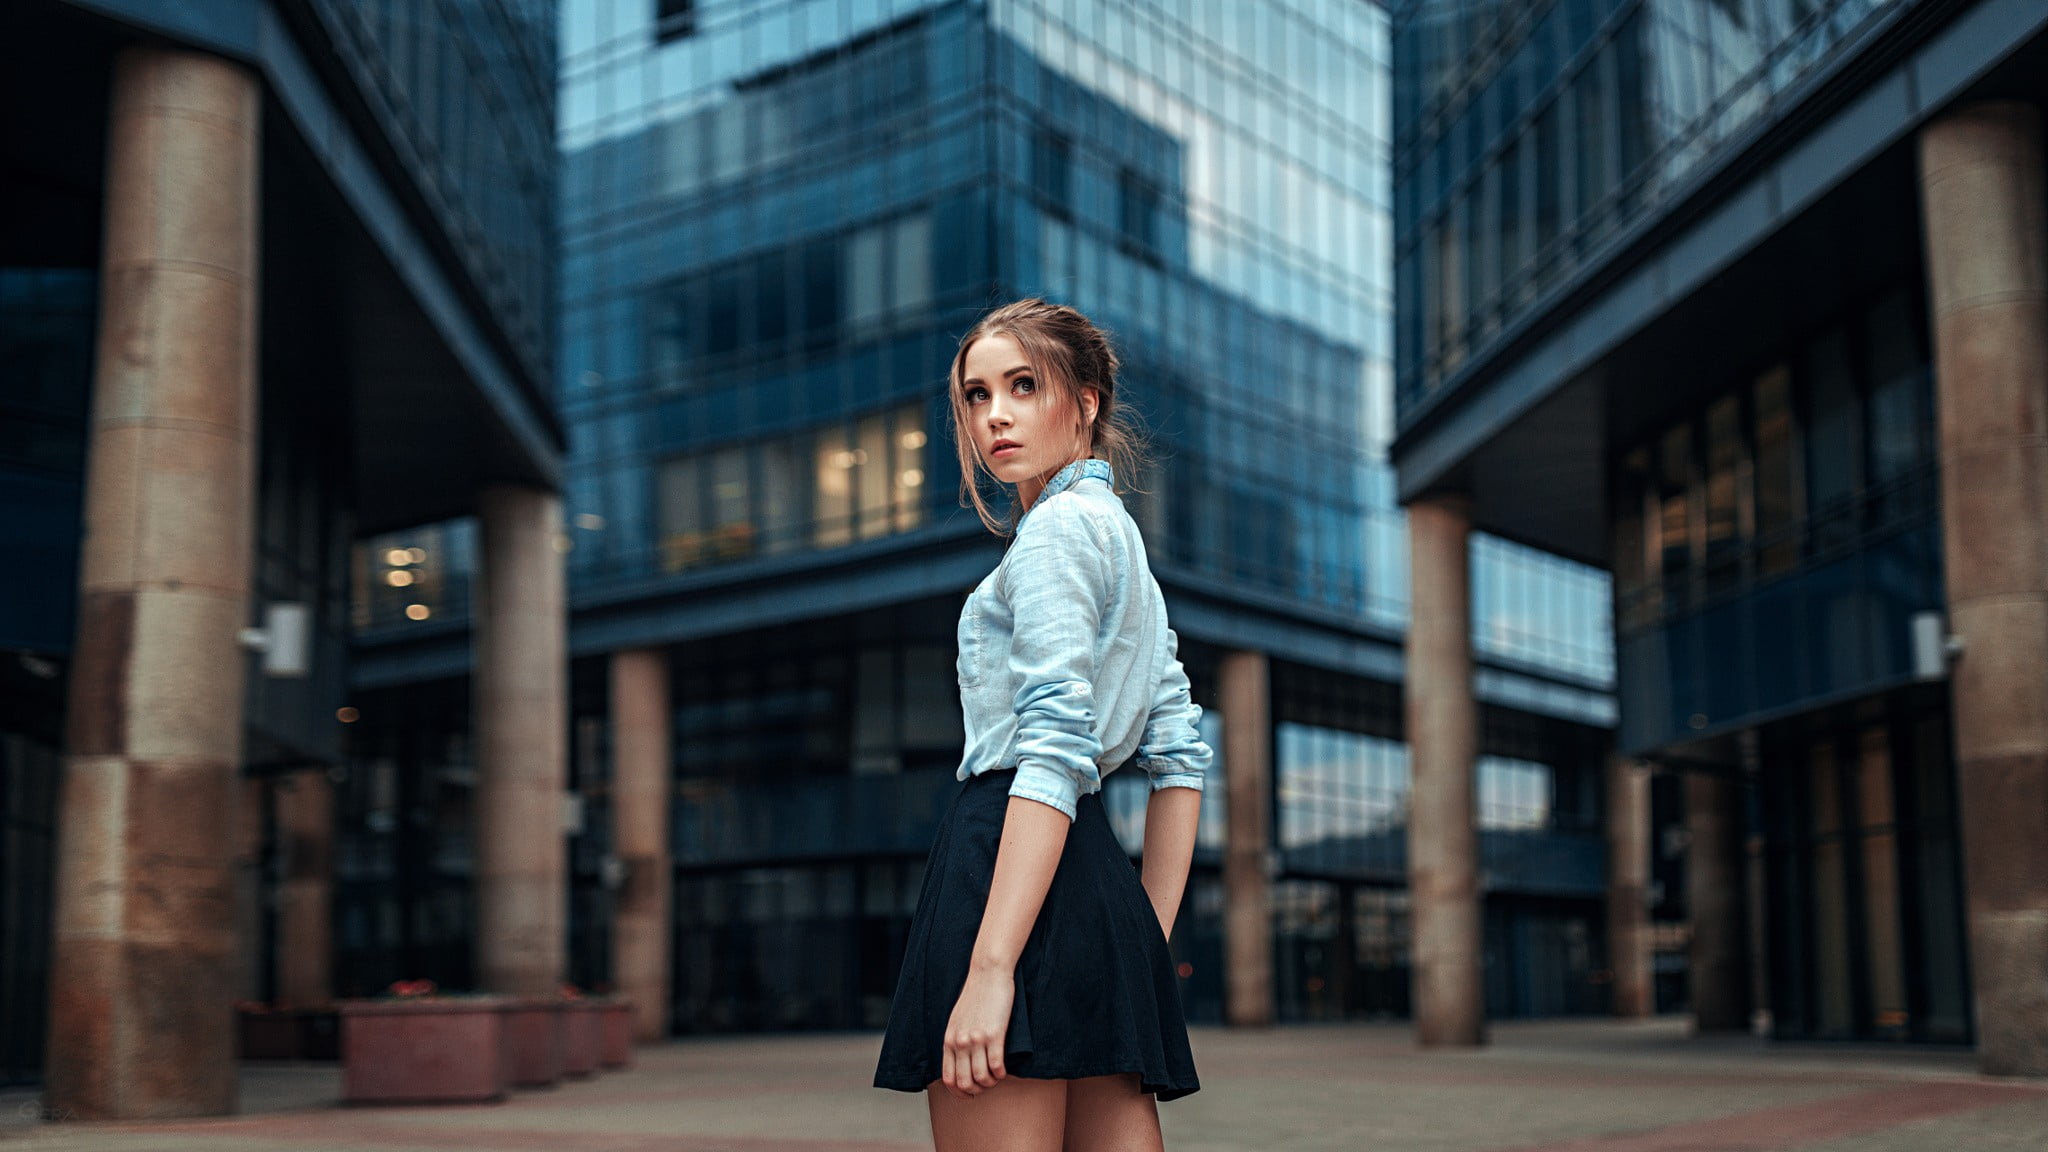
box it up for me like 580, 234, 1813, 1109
940, 795, 1073, 1097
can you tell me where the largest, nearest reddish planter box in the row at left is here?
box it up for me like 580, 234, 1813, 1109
340, 996, 510, 1105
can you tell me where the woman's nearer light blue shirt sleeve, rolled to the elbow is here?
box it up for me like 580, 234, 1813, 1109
1004, 498, 1110, 820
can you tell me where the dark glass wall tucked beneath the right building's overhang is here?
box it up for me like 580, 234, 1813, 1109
1612, 283, 1944, 748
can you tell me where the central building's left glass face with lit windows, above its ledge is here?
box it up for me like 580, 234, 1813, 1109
557, 0, 995, 588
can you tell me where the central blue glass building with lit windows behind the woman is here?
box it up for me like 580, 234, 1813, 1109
338, 0, 1614, 1031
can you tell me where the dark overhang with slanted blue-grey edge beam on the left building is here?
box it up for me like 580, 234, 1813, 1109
41, 0, 567, 535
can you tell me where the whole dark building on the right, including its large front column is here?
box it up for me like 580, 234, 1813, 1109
1393, 0, 2048, 1074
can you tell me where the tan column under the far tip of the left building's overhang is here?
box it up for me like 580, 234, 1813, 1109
475, 486, 569, 996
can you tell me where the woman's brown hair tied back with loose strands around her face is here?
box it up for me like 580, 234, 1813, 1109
946, 297, 1149, 535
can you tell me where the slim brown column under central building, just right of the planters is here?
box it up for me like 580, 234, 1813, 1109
612, 648, 674, 1043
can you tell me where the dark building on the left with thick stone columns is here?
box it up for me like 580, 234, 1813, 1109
0, 0, 563, 1117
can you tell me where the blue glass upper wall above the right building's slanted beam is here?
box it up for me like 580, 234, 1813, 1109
1391, 0, 1907, 409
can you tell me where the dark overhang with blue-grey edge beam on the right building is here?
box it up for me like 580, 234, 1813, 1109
1389, 0, 2048, 568
